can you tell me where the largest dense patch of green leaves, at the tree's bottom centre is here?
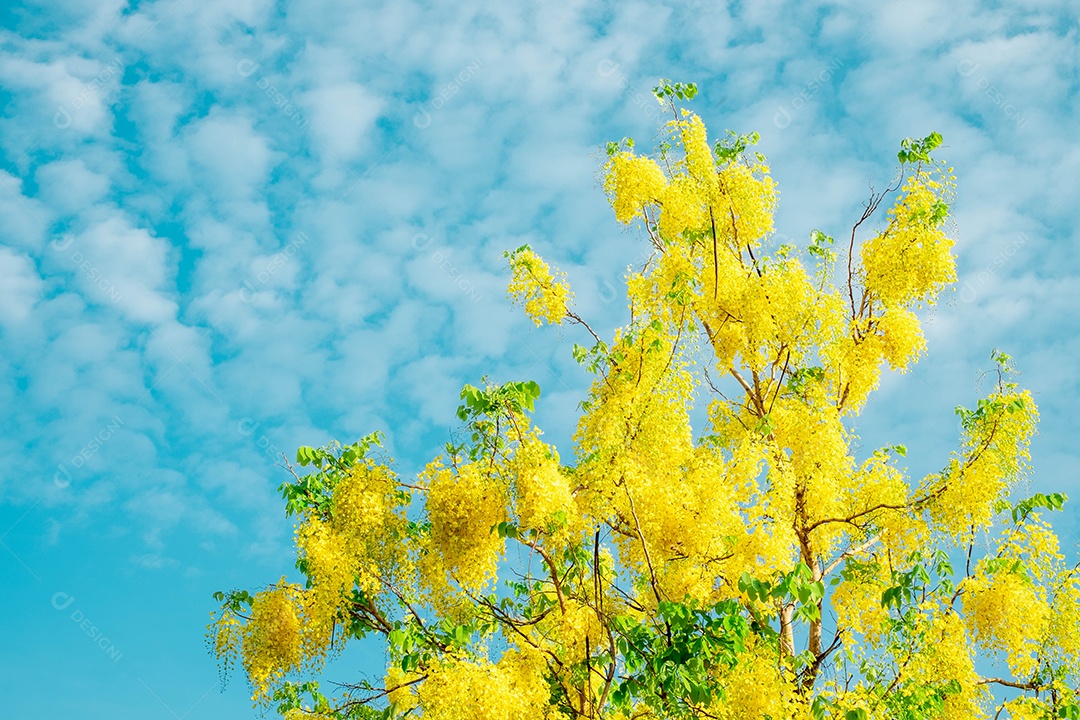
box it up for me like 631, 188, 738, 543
611, 600, 751, 718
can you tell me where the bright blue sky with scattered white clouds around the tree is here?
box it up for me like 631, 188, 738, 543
0, 0, 1080, 720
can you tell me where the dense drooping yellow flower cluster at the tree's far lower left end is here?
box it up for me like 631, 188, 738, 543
242, 578, 302, 699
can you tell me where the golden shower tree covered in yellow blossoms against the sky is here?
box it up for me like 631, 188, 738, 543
208, 81, 1080, 720
